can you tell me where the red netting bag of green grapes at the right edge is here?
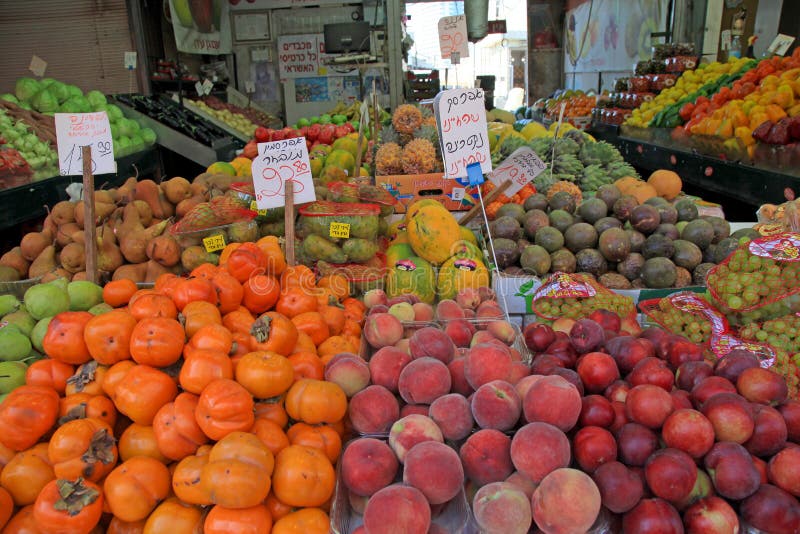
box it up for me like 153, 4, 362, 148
706, 233, 800, 325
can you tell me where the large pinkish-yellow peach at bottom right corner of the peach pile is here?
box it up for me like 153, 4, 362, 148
531, 468, 601, 532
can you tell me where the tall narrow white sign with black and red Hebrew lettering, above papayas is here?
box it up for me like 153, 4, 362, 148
433, 89, 492, 178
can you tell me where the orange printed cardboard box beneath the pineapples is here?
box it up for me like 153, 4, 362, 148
375, 172, 477, 213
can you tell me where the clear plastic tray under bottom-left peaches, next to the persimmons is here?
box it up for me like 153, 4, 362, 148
330, 436, 471, 534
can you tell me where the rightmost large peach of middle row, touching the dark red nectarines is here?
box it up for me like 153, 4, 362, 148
522, 376, 580, 432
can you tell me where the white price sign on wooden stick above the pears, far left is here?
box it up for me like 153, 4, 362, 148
55, 111, 117, 176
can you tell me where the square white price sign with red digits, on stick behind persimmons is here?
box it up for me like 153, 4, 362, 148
251, 137, 317, 210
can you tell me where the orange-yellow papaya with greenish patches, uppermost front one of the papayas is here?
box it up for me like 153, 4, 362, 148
406, 206, 461, 265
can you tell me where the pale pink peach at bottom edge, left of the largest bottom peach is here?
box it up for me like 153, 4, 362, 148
472, 482, 533, 534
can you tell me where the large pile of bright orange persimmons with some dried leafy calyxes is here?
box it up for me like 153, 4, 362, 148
0, 238, 364, 534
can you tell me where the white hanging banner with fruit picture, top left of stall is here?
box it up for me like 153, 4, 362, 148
169, 0, 231, 55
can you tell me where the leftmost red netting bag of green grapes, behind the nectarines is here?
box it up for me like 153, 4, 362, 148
531, 273, 636, 321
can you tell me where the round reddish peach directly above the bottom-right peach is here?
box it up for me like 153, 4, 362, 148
511, 423, 570, 484
